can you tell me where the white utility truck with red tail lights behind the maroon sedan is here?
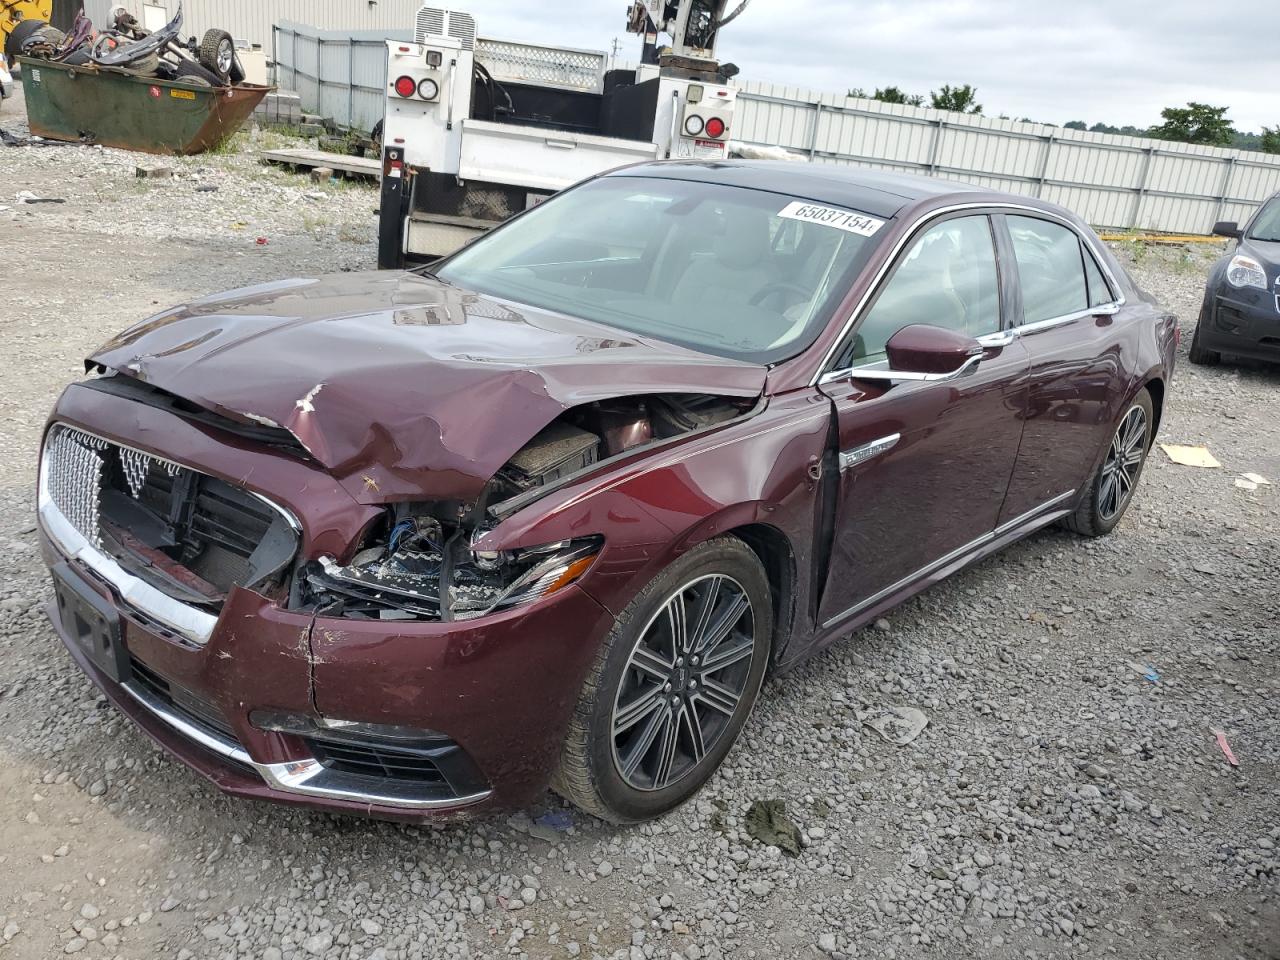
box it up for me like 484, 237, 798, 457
378, 7, 737, 269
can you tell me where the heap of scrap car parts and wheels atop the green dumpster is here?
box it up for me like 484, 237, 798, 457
5, 4, 244, 87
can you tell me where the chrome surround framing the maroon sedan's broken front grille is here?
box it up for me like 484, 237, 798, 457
36, 421, 302, 646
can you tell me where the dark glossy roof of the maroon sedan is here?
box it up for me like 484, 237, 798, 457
609, 160, 988, 216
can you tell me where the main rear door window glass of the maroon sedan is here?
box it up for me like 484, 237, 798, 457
1005, 216, 1090, 324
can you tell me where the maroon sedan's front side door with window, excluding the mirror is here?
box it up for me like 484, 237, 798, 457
819, 212, 1029, 627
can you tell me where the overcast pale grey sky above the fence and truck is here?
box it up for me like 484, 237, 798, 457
456, 0, 1280, 132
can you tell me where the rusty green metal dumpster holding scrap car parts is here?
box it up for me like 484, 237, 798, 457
18, 56, 273, 154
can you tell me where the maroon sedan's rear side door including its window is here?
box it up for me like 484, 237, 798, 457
996, 212, 1126, 524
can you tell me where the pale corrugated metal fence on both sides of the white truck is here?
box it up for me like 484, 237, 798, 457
273, 22, 1280, 233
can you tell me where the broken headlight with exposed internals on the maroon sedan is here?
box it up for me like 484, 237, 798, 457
307, 518, 604, 621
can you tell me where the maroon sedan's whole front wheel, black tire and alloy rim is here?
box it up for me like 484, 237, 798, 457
552, 536, 774, 823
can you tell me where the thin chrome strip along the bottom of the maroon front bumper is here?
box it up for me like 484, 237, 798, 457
123, 684, 493, 810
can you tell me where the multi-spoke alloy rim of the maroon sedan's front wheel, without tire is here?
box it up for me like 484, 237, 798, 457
609, 573, 755, 791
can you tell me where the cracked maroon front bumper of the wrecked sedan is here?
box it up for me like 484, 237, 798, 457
40, 388, 612, 820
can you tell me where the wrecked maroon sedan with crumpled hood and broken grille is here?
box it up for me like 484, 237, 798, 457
40, 163, 1178, 822
